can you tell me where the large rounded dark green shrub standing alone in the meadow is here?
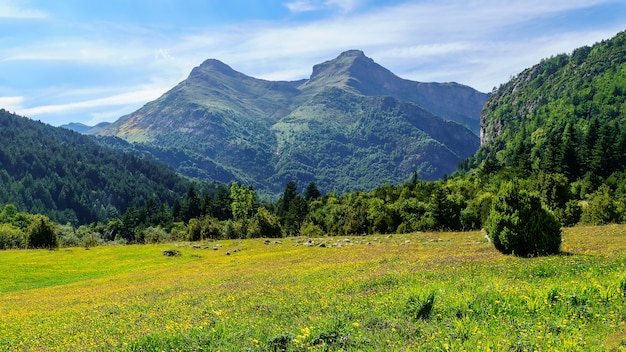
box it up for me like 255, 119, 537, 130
486, 182, 561, 256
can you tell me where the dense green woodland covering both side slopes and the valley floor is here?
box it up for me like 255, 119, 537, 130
0, 33, 626, 248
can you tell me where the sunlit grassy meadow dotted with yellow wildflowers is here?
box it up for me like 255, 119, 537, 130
0, 226, 626, 351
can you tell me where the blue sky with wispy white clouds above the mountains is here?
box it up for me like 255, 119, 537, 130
0, 0, 626, 125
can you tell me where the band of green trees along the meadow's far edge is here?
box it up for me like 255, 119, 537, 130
0, 162, 626, 248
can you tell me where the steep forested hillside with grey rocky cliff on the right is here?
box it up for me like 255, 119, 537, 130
465, 32, 626, 186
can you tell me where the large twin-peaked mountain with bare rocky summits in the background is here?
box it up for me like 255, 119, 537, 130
99, 50, 486, 194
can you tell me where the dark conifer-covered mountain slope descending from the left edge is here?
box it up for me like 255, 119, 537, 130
0, 109, 189, 224
